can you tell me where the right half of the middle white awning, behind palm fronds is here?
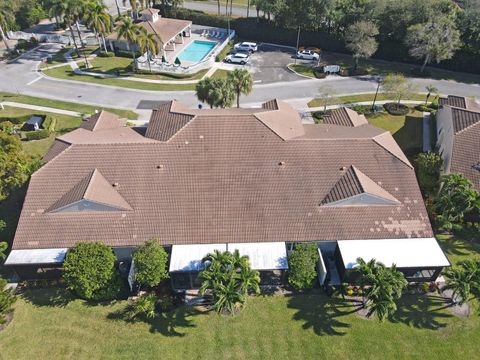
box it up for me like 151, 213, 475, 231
227, 242, 288, 270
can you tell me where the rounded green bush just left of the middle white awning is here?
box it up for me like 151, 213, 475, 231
133, 239, 169, 287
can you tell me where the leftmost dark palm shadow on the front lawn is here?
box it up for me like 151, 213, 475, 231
107, 306, 208, 337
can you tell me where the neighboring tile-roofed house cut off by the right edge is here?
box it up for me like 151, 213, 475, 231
436, 95, 480, 191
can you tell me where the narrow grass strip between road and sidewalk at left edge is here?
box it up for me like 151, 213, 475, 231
0, 92, 138, 120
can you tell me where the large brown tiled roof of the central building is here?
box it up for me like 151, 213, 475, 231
13, 101, 432, 249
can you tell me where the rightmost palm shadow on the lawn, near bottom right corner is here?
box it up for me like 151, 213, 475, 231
389, 295, 452, 330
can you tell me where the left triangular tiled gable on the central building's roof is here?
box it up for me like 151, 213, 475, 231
47, 169, 132, 212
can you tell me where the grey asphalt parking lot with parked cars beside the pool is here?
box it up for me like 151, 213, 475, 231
225, 44, 313, 84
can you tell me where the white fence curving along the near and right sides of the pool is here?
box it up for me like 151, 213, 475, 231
136, 30, 235, 74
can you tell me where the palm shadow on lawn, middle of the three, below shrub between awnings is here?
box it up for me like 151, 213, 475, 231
288, 295, 356, 336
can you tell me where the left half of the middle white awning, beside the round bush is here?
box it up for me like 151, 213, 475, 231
170, 244, 227, 272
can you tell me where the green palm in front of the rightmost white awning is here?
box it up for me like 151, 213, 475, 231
357, 258, 407, 321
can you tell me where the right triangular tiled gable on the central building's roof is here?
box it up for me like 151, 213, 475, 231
321, 165, 400, 206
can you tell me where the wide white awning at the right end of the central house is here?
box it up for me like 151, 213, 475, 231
338, 238, 450, 269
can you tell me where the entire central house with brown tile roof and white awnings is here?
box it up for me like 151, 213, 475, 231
6, 100, 449, 289
